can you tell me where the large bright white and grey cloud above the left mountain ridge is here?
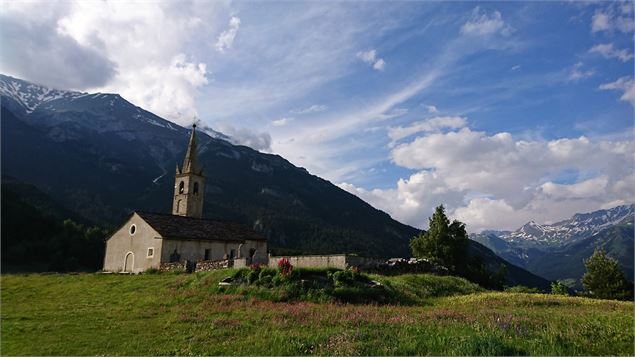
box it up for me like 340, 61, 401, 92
0, 1, 219, 124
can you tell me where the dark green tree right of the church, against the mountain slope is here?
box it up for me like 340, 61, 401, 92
410, 205, 468, 271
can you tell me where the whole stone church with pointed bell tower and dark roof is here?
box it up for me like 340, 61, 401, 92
104, 125, 268, 273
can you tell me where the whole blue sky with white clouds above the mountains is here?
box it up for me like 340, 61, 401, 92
0, 1, 635, 232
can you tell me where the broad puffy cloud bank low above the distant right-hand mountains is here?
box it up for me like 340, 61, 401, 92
340, 127, 635, 232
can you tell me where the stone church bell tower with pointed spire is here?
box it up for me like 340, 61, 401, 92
172, 124, 205, 218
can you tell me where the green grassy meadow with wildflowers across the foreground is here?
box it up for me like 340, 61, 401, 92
0, 271, 634, 355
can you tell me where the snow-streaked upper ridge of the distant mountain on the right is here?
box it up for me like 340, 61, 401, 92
496, 205, 635, 246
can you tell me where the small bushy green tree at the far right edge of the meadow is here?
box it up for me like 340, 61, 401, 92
582, 248, 632, 299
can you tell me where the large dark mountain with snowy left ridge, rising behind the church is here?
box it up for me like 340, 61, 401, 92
0, 75, 547, 286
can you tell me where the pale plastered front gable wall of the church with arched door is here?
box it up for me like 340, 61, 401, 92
104, 213, 162, 273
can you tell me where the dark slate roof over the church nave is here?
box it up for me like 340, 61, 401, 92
136, 212, 266, 242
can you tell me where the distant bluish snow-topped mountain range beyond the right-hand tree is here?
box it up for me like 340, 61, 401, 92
470, 204, 635, 288
